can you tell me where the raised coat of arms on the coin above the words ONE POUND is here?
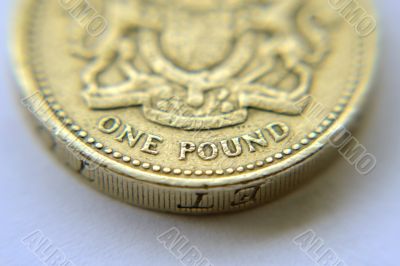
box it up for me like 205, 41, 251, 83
74, 0, 333, 130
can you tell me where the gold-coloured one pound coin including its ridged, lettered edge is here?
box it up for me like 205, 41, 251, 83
15, 0, 377, 214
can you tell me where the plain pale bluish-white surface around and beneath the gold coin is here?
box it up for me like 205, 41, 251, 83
0, 0, 400, 266
